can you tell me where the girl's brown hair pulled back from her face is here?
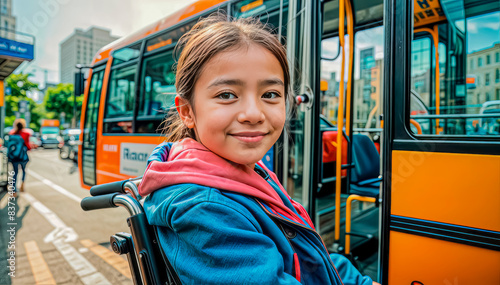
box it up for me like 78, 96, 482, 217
164, 13, 293, 142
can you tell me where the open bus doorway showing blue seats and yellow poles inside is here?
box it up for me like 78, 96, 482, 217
314, 0, 384, 280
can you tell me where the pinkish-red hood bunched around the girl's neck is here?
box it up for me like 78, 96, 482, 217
139, 139, 313, 228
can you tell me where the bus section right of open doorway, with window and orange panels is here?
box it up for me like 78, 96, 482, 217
381, 0, 500, 284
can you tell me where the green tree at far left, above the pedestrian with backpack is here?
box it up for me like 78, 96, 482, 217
5, 73, 45, 131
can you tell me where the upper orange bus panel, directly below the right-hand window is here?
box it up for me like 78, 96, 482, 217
391, 151, 500, 232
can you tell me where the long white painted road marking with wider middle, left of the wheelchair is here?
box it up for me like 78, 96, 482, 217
21, 193, 111, 285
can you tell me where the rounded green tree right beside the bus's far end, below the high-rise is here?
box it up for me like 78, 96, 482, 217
44, 83, 83, 125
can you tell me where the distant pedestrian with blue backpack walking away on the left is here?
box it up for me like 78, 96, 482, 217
7, 119, 31, 195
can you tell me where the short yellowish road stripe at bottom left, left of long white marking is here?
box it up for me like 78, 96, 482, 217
24, 240, 56, 285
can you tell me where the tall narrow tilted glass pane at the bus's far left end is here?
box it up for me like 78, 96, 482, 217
82, 70, 104, 185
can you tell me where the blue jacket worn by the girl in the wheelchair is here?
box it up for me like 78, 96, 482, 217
144, 166, 372, 284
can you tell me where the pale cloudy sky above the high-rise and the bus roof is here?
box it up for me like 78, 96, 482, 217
12, 0, 194, 87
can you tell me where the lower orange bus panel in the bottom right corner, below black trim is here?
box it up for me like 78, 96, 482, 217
389, 231, 500, 285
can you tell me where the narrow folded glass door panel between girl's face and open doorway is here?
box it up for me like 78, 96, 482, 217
282, 1, 321, 222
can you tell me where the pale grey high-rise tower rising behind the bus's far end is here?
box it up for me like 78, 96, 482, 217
59, 26, 119, 83
